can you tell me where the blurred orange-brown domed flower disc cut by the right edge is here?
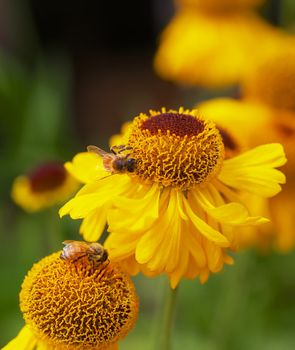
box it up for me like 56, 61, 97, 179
244, 45, 295, 112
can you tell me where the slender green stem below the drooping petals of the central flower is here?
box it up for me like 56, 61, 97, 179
157, 286, 178, 350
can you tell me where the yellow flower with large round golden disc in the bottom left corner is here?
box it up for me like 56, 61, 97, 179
4, 252, 138, 350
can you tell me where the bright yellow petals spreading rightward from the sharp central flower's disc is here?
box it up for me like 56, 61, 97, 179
218, 143, 286, 197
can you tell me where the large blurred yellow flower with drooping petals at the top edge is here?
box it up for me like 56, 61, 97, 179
154, 1, 282, 87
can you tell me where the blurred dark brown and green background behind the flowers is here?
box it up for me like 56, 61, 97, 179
0, 0, 295, 350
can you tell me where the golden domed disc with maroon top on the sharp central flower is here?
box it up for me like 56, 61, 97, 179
128, 109, 224, 189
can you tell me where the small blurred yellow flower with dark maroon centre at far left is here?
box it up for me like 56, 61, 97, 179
11, 162, 79, 212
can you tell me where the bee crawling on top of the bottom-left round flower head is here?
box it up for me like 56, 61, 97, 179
60, 240, 108, 268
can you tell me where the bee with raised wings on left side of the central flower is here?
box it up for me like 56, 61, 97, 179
87, 145, 136, 174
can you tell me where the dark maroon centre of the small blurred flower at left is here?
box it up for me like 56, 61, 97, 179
29, 162, 66, 192
